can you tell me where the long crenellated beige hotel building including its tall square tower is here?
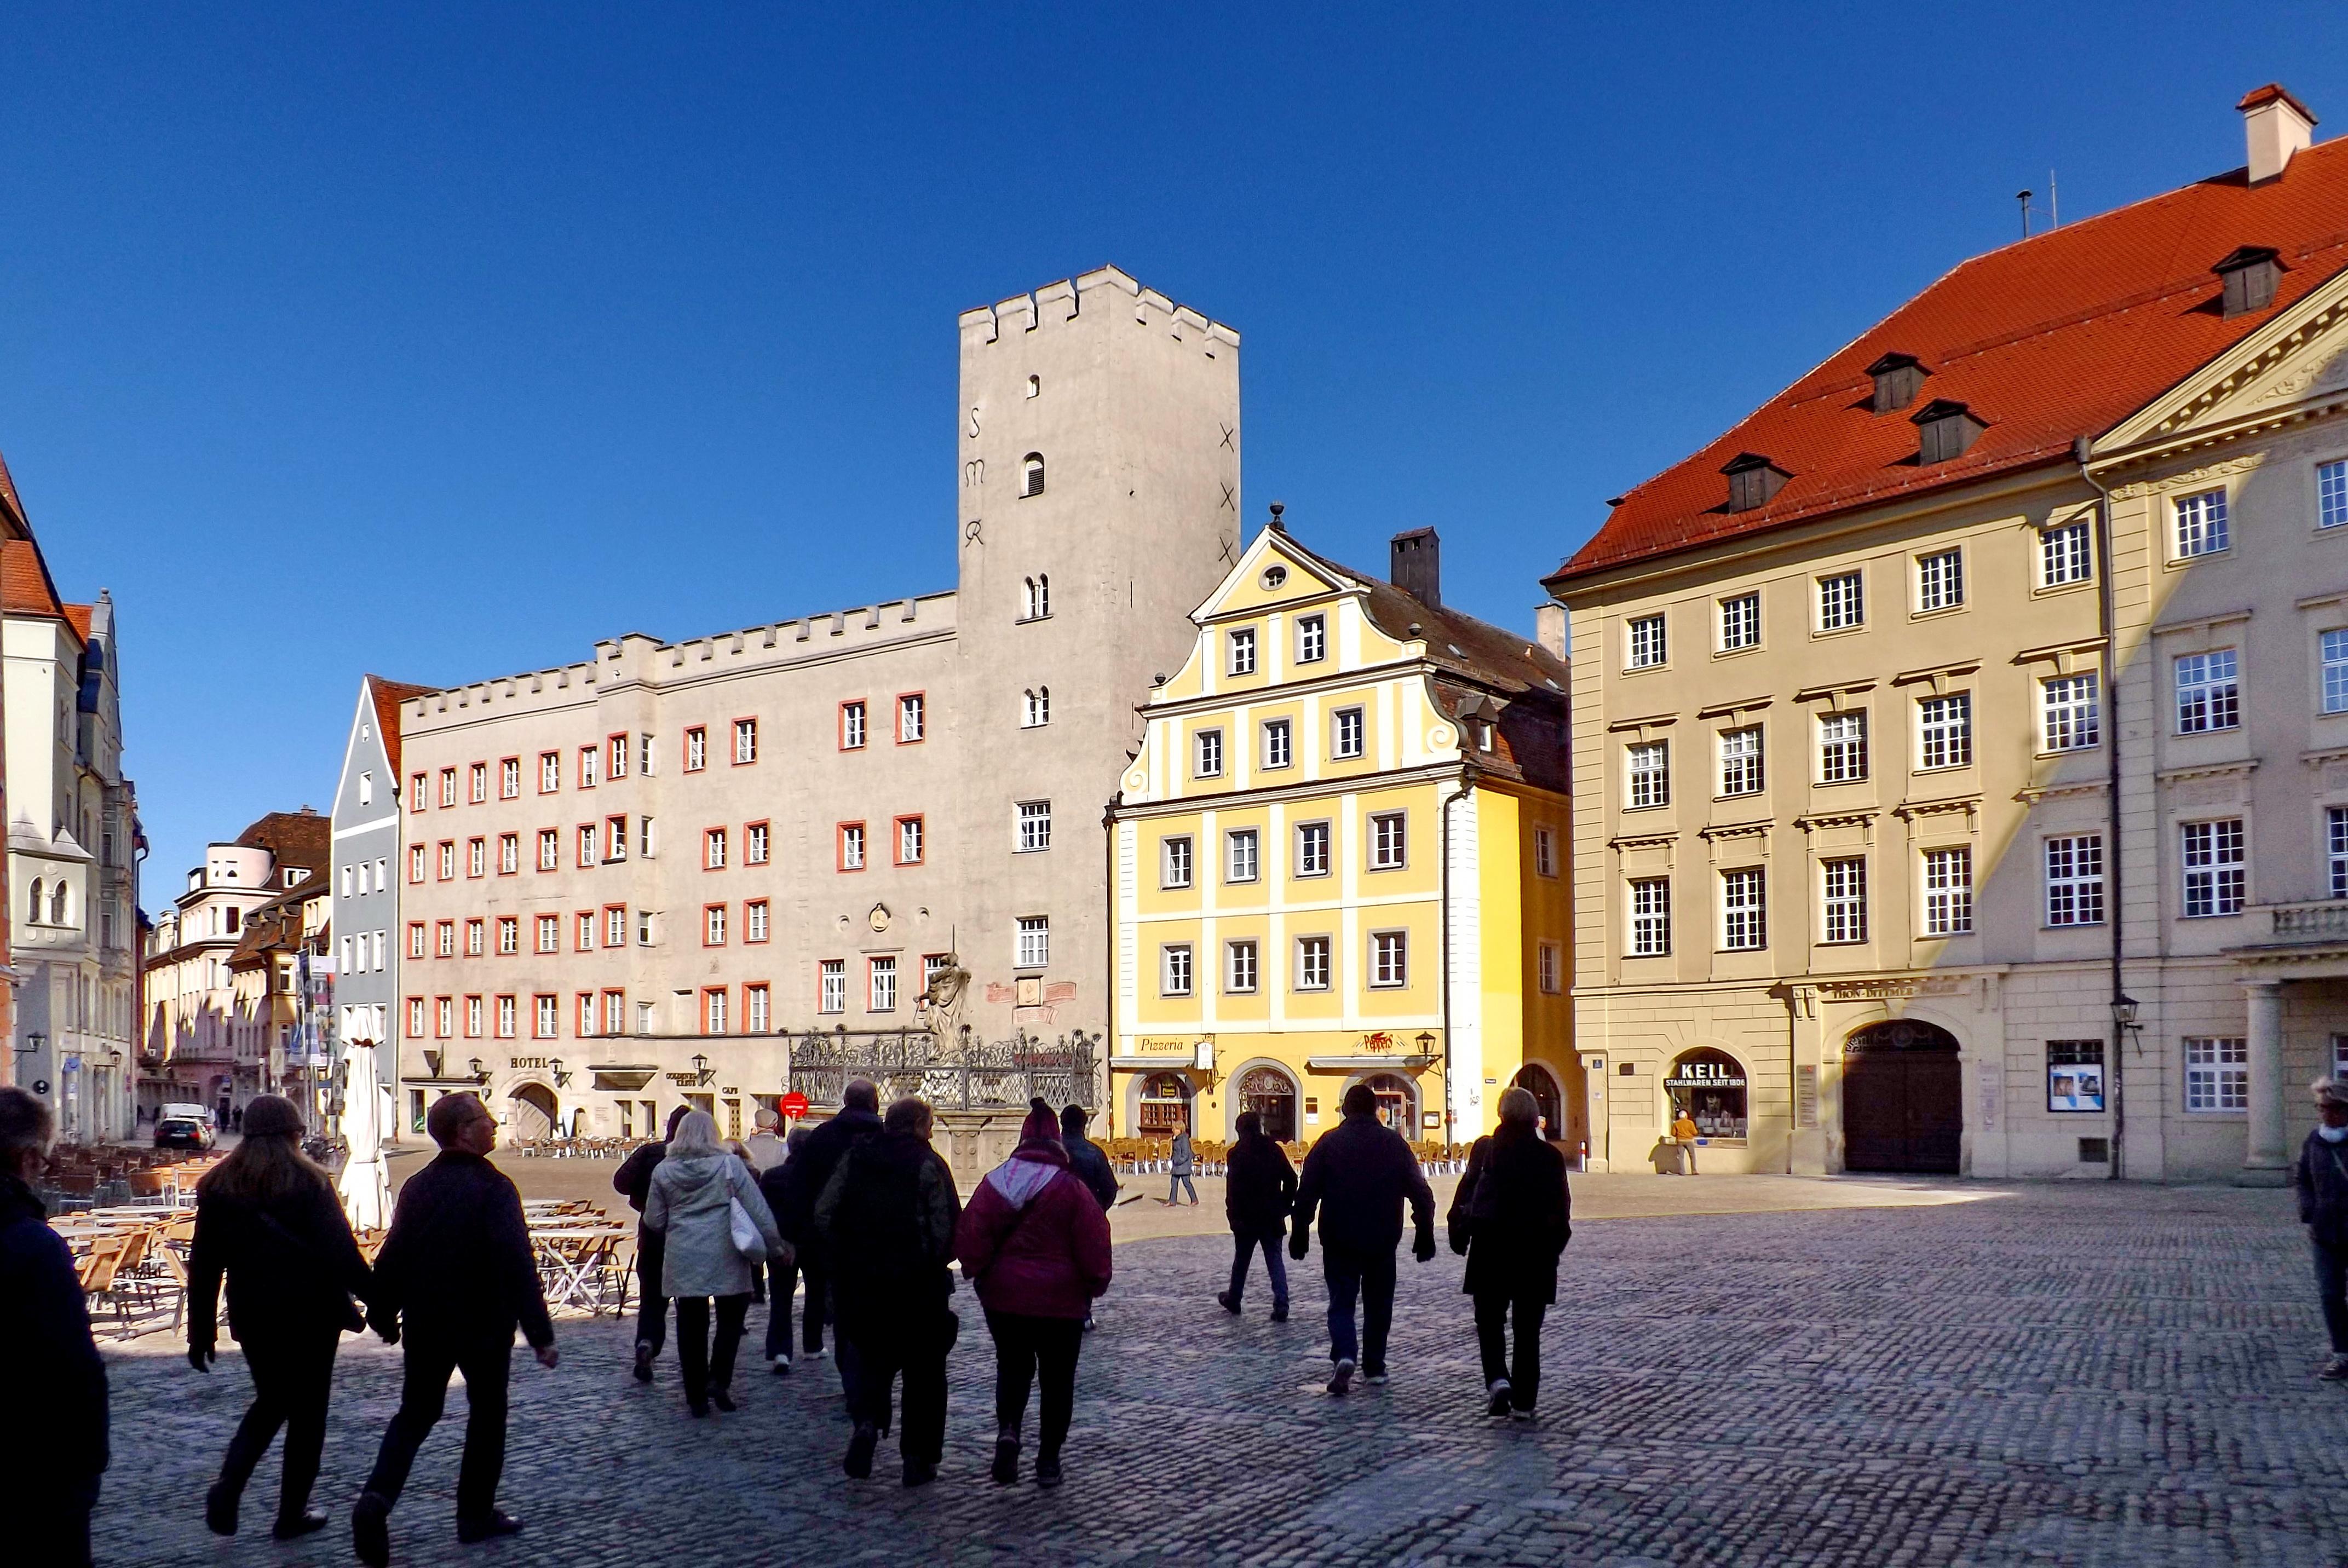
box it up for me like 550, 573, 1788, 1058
387, 268, 1240, 1136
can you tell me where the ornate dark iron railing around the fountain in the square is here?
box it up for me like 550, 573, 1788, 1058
791, 1026, 1101, 1110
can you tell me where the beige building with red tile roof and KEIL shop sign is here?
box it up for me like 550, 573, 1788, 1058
1550, 89, 2348, 1181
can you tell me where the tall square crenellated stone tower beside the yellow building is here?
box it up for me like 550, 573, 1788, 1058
951, 268, 1242, 1037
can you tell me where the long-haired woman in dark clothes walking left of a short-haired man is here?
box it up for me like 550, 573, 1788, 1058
188, 1094, 373, 1540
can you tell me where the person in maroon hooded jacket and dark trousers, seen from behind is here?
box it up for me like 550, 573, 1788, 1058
953, 1101, 1110, 1486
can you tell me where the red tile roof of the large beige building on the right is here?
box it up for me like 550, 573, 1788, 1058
1547, 125, 2348, 585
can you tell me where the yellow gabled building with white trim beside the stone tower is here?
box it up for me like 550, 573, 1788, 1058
1108, 507, 1585, 1145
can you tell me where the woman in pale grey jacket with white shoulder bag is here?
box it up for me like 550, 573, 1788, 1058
643, 1110, 791, 1415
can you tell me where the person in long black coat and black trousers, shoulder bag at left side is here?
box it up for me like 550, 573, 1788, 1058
1451, 1089, 1573, 1420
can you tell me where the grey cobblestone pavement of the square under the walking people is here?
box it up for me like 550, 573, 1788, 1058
99, 1183, 2348, 1568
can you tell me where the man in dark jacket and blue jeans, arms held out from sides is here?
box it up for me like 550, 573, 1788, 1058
1289, 1085, 1435, 1394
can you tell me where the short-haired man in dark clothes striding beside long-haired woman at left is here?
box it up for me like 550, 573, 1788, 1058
350, 1094, 556, 1568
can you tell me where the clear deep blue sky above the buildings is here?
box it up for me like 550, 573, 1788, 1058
0, 2, 2348, 887
